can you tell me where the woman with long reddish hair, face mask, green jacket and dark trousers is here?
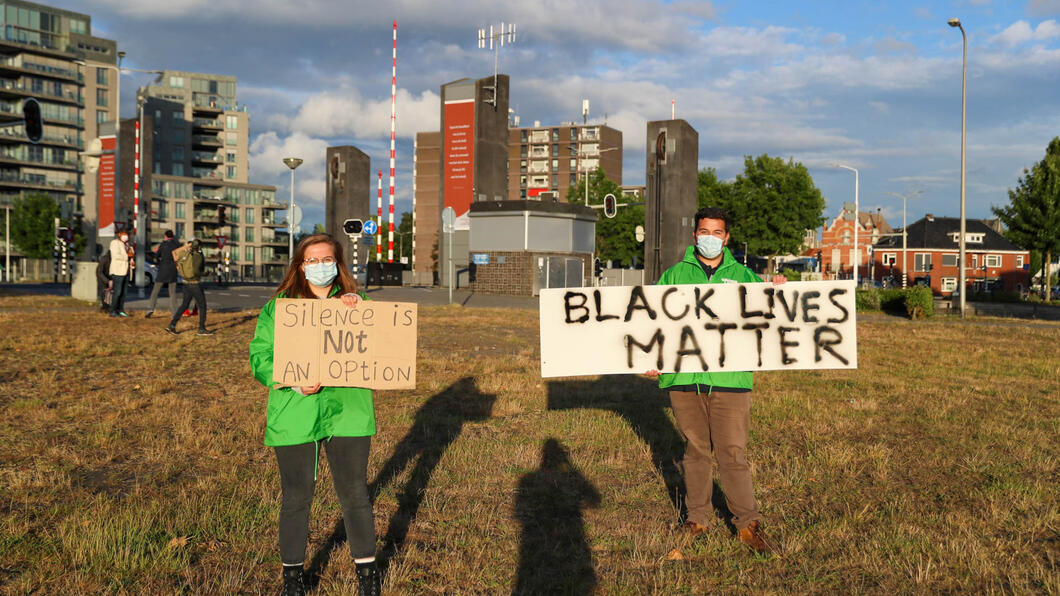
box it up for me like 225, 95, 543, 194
250, 234, 381, 595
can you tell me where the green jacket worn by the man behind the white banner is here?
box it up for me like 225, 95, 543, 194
658, 246, 762, 392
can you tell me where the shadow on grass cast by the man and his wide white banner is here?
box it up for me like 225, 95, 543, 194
548, 374, 736, 532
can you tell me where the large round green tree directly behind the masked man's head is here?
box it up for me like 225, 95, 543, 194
720, 154, 825, 270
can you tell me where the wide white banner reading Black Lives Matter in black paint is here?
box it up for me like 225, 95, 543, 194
540, 281, 858, 376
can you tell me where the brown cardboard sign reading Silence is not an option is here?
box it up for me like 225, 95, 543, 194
272, 298, 418, 389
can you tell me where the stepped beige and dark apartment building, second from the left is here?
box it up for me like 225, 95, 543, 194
136, 70, 288, 280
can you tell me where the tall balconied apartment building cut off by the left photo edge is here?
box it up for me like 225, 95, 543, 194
0, 0, 118, 230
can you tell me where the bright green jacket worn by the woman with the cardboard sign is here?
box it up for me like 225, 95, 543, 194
250, 287, 375, 446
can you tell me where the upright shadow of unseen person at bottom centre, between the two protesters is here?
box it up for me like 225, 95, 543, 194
512, 438, 600, 595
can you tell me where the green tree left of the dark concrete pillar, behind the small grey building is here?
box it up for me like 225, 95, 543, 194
567, 168, 644, 266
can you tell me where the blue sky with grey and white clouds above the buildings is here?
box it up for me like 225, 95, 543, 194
68, 0, 1060, 228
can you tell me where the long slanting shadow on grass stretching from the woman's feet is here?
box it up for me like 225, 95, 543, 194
308, 376, 497, 585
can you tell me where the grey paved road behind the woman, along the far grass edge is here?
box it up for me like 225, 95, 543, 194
0, 283, 537, 313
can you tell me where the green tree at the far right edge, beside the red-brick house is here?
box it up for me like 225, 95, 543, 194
991, 137, 1060, 297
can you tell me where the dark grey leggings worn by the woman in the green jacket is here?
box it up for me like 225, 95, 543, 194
273, 437, 375, 565
